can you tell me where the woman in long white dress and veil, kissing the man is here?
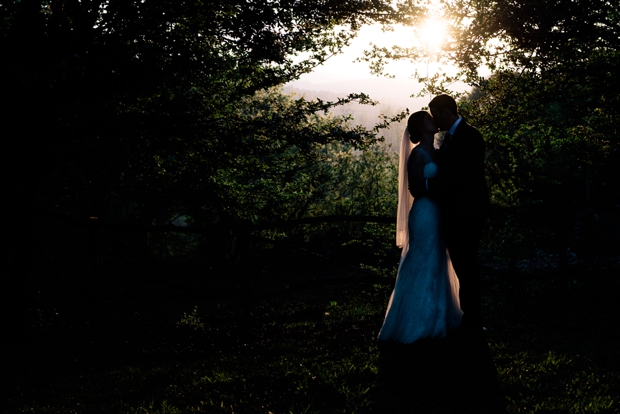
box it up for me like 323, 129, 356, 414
377, 111, 463, 343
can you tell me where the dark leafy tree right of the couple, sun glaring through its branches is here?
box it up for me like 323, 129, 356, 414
451, 0, 620, 207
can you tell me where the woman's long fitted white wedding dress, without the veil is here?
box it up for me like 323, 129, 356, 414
377, 148, 463, 343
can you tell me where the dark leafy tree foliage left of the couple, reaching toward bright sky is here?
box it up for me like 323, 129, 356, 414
0, 0, 417, 278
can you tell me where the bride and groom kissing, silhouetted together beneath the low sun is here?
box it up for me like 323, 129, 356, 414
378, 95, 489, 343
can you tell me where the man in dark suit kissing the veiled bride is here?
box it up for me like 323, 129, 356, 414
428, 94, 489, 332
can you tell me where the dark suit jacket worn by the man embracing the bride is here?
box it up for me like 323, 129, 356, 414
431, 119, 489, 224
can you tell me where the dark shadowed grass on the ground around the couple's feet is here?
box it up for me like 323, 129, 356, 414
0, 254, 620, 414
